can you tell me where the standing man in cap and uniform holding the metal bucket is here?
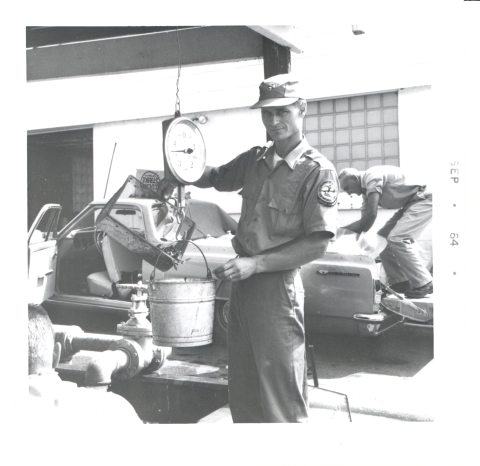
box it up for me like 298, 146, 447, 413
172, 74, 338, 422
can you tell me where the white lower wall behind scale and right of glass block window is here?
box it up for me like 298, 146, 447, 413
93, 86, 433, 214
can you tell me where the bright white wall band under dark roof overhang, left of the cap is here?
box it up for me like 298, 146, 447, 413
25, 60, 263, 130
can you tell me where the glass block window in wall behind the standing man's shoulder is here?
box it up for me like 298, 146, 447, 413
303, 92, 400, 171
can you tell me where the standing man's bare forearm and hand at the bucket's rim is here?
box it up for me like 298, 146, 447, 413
213, 231, 331, 281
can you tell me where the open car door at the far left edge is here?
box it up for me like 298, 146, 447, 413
27, 204, 62, 304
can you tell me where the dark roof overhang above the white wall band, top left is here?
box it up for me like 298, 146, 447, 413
27, 26, 300, 81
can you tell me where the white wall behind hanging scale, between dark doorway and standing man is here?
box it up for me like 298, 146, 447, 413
93, 108, 266, 213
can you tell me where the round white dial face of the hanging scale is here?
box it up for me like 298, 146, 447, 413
163, 117, 206, 184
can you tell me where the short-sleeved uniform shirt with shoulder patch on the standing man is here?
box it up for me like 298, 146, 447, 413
211, 138, 338, 256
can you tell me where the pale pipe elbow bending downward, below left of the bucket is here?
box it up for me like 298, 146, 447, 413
85, 350, 130, 387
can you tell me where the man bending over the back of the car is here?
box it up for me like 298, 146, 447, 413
338, 165, 433, 298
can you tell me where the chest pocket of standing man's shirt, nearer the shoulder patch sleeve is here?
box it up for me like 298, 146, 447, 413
268, 197, 302, 238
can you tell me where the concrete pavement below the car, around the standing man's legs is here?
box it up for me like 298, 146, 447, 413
199, 326, 435, 423
